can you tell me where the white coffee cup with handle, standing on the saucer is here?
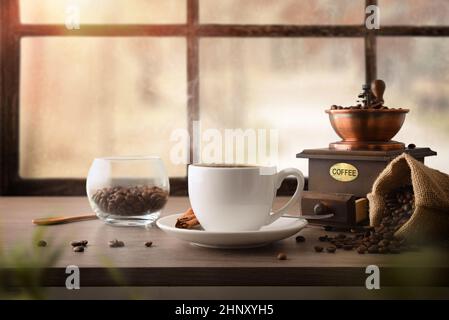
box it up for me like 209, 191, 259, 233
188, 165, 304, 232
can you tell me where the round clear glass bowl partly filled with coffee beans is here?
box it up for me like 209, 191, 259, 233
86, 156, 170, 226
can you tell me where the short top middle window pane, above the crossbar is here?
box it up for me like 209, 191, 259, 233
200, 0, 365, 25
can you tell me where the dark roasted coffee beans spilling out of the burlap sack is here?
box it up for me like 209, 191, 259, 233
315, 186, 417, 254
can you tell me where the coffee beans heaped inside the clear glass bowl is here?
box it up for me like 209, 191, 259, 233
92, 186, 168, 216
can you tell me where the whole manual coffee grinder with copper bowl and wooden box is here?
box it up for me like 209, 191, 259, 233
296, 80, 436, 228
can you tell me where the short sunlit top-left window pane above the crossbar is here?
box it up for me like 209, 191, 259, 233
20, 0, 186, 24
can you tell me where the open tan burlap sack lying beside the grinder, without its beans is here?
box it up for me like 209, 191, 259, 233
368, 154, 449, 241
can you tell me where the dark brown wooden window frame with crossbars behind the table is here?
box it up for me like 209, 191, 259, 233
0, 0, 449, 196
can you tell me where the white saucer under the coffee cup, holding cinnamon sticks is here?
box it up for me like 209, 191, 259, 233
156, 214, 307, 249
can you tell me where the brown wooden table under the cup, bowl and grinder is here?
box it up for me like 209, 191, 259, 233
0, 197, 449, 287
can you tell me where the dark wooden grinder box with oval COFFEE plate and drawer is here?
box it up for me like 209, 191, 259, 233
296, 148, 436, 227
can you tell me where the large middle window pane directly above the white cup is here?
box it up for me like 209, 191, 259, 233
200, 38, 365, 172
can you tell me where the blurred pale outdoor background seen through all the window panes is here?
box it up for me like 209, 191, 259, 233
19, 0, 449, 178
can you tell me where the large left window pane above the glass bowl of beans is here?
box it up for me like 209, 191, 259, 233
20, 37, 187, 178
